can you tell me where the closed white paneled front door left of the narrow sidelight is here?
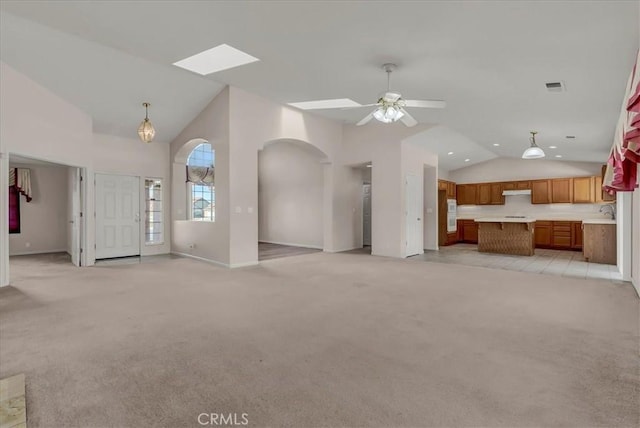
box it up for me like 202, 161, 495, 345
96, 174, 140, 259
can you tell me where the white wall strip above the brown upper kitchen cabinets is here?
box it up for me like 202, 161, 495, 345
449, 158, 602, 184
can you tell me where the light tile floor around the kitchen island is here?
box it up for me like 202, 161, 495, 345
409, 244, 624, 284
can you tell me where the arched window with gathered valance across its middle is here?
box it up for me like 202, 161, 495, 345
187, 143, 216, 221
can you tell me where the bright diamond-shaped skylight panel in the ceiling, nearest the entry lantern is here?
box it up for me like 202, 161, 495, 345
173, 44, 260, 76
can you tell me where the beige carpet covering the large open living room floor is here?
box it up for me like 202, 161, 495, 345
0, 253, 640, 427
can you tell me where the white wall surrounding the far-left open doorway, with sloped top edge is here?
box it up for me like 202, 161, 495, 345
0, 63, 95, 286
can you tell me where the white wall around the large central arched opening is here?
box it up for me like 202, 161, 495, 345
226, 87, 342, 266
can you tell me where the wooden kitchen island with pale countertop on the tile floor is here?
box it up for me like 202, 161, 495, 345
475, 216, 536, 256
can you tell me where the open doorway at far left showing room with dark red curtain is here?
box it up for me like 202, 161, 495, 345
8, 154, 86, 281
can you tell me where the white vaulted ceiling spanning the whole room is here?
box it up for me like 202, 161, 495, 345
0, 0, 640, 169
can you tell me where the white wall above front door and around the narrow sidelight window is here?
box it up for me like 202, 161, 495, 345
89, 134, 171, 256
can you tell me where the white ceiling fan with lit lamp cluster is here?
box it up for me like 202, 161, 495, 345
356, 63, 446, 126
